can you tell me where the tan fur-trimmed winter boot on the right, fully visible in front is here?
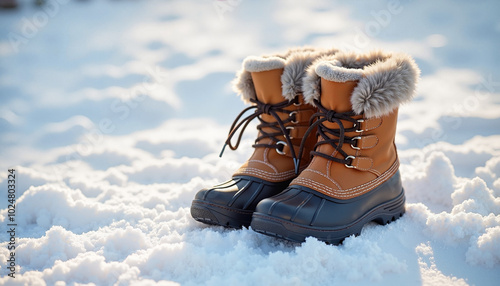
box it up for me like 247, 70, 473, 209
251, 52, 420, 244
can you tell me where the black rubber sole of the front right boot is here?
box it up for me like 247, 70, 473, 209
251, 191, 405, 244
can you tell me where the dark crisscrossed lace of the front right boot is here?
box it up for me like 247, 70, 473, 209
296, 100, 362, 172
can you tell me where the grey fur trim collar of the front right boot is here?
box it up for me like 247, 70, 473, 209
304, 51, 420, 118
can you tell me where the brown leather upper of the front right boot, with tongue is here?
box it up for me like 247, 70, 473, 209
292, 79, 399, 199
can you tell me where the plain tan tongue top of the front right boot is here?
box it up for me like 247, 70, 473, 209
320, 78, 358, 112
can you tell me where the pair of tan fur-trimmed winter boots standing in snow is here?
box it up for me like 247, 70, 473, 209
191, 48, 420, 244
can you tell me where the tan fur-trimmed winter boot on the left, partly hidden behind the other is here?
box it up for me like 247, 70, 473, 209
191, 48, 336, 228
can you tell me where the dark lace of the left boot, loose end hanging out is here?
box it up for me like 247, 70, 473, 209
219, 97, 299, 169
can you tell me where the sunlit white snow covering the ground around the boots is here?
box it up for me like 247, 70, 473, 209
0, 0, 500, 285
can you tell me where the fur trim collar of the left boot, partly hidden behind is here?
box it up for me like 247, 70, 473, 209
233, 47, 337, 103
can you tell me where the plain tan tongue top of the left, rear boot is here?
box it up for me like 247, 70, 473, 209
251, 68, 285, 104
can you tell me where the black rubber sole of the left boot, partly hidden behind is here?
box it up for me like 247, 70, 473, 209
191, 200, 253, 228
